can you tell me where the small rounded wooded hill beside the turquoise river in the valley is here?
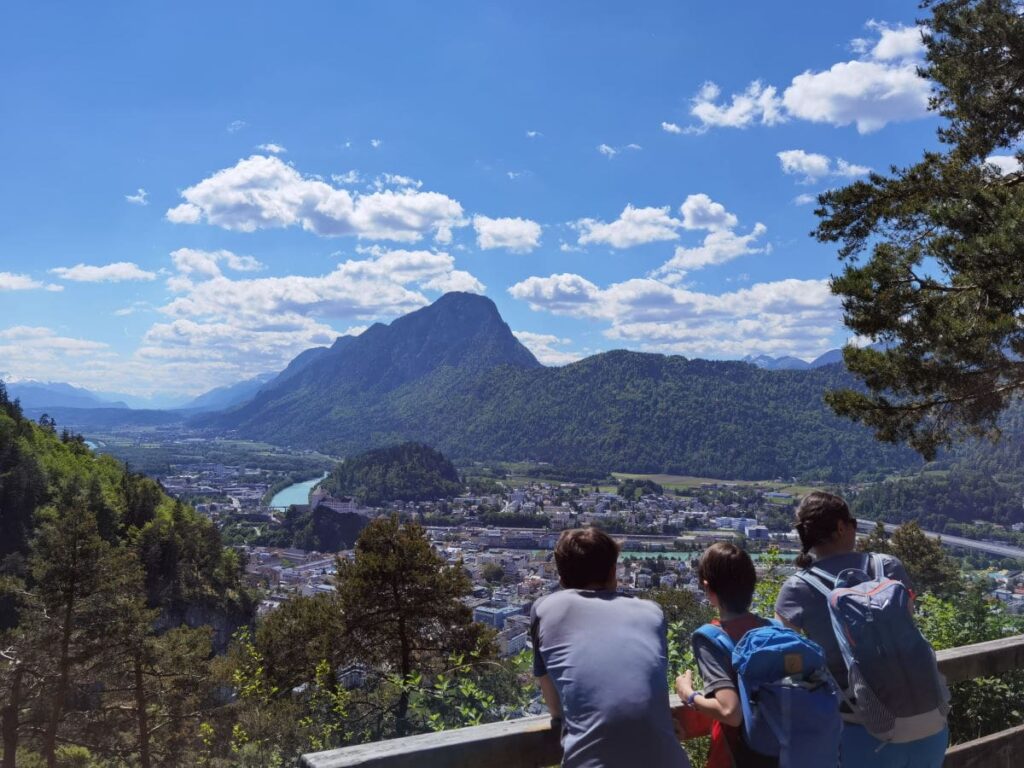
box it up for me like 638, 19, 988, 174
321, 442, 463, 506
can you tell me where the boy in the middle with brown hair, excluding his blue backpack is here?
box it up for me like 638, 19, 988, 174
676, 542, 778, 768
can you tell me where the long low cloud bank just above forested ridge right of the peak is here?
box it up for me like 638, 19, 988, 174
509, 274, 842, 357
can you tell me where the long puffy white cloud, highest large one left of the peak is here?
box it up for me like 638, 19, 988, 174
167, 155, 465, 242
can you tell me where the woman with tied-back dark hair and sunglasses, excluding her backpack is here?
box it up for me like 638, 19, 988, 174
775, 490, 949, 768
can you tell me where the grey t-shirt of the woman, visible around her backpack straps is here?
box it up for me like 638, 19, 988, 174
775, 552, 910, 688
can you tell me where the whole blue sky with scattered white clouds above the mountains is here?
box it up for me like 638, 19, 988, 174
0, 0, 958, 395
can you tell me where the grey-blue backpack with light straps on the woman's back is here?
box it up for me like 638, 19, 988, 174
797, 555, 949, 742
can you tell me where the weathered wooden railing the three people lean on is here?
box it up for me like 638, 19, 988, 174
301, 635, 1024, 768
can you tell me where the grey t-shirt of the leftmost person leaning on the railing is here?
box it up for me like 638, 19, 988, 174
531, 590, 689, 768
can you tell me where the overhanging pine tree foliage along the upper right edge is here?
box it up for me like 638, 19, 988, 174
815, 0, 1024, 459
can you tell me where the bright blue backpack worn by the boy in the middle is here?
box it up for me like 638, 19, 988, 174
696, 622, 843, 768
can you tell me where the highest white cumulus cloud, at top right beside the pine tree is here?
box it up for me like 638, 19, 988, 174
675, 22, 931, 133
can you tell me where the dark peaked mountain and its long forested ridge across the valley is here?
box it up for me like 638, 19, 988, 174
6, 293, 920, 479
